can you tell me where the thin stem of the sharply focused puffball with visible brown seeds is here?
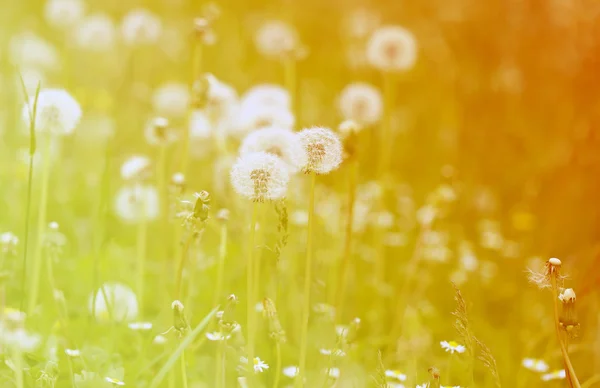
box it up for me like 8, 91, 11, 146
295, 172, 317, 387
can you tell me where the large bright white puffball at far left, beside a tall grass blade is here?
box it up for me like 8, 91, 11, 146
22, 89, 81, 135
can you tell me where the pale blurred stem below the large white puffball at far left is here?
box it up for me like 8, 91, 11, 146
27, 136, 52, 315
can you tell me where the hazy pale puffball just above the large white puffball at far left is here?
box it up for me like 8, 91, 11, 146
9, 32, 60, 71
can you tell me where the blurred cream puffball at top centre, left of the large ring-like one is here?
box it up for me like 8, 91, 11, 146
254, 20, 299, 58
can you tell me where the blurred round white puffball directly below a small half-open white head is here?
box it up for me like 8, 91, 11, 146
115, 184, 160, 223
